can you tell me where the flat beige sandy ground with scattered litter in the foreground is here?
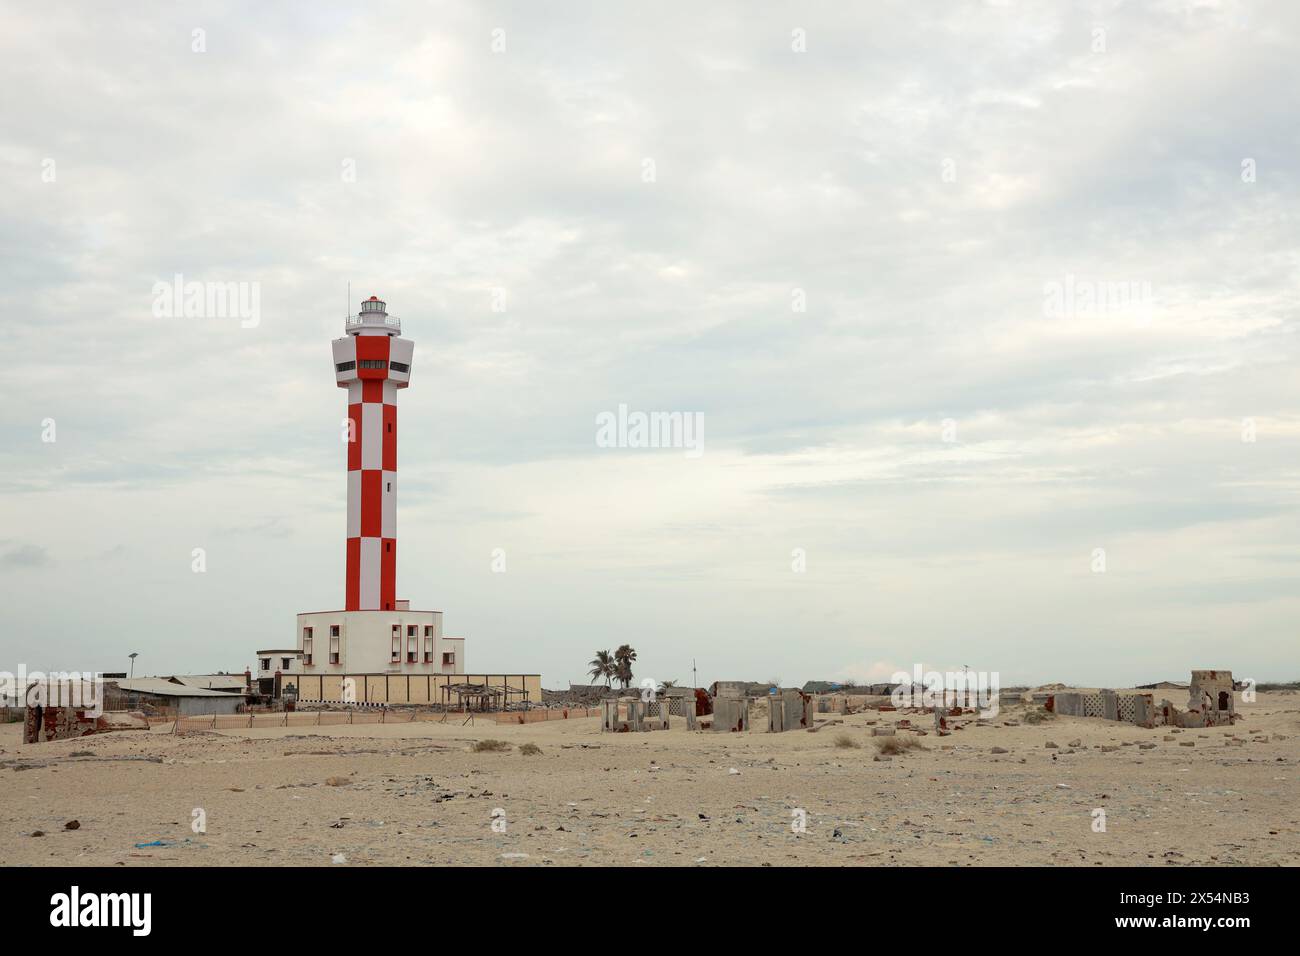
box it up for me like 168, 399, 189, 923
0, 693, 1300, 866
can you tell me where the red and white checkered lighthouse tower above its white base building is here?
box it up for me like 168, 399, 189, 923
334, 295, 415, 611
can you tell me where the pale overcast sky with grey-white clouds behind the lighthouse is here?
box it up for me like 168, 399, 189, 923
0, 0, 1300, 687
